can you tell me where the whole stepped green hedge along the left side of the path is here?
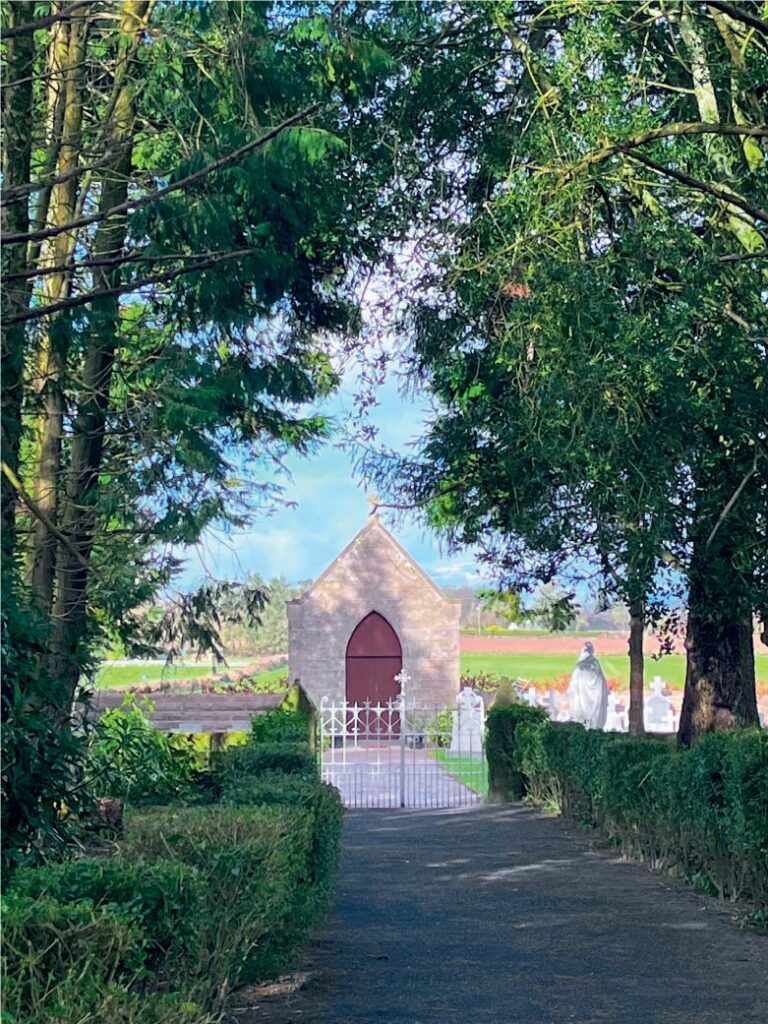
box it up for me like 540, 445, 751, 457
3, 712, 342, 1024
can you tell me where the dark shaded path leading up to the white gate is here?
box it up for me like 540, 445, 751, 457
247, 807, 768, 1024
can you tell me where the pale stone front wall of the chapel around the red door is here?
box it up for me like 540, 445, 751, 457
288, 525, 461, 705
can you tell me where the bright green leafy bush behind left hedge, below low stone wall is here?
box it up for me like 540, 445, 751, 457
88, 695, 197, 805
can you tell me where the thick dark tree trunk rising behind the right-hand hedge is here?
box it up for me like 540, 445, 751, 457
678, 544, 759, 746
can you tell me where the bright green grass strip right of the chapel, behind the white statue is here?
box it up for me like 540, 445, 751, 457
461, 651, 768, 687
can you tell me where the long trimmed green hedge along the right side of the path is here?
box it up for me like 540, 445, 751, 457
487, 709, 768, 919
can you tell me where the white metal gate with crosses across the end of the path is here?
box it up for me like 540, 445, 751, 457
317, 697, 487, 808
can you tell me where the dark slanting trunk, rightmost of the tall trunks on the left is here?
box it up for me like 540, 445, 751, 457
48, 0, 151, 700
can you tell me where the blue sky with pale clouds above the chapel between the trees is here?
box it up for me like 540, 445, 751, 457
181, 378, 482, 587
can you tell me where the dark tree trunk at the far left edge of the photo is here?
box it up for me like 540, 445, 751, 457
0, 0, 35, 556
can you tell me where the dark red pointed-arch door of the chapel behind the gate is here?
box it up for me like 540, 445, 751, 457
346, 611, 402, 731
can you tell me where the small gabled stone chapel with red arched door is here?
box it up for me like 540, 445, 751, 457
288, 515, 461, 706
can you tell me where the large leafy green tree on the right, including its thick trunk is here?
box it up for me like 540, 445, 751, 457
366, 2, 768, 733
